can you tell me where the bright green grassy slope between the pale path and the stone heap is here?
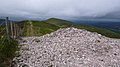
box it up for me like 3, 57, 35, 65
33, 21, 59, 36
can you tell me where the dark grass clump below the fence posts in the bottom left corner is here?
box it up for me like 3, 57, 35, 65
0, 39, 18, 67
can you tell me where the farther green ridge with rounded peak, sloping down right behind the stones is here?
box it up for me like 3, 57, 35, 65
46, 18, 120, 38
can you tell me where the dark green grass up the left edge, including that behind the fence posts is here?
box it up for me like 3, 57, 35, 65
0, 26, 18, 67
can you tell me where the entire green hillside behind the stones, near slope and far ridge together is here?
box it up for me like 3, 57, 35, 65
17, 18, 120, 38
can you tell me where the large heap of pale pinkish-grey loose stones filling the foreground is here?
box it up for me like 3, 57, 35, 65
12, 28, 120, 67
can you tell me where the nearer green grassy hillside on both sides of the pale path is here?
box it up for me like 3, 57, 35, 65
17, 21, 60, 36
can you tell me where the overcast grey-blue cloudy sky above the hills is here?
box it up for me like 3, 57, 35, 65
0, 0, 120, 19
